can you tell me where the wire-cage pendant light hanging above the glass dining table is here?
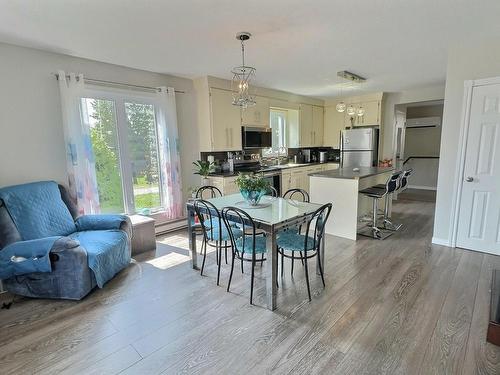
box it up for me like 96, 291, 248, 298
231, 31, 255, 108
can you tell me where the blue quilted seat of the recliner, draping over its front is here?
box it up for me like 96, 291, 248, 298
69, 230, 131, 288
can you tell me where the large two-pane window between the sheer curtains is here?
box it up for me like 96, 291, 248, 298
81, 95, 163, 214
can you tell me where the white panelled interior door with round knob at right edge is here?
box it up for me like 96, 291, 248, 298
457, 84, 500, 255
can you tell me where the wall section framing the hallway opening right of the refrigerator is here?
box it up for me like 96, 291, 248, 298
382, 83, 444, 159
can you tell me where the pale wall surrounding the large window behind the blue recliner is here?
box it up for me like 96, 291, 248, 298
0, 43, 199, 203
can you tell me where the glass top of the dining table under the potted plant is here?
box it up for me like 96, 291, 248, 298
191, 193, 321, 225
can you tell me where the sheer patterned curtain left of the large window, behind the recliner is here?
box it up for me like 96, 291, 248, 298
57, 70, 100, 215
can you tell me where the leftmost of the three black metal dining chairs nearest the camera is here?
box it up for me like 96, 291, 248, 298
194, 199, 242, 285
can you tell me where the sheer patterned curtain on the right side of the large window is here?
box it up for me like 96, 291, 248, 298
156, 87, 183, 220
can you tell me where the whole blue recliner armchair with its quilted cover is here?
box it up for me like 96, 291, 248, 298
0, 181, 132, 300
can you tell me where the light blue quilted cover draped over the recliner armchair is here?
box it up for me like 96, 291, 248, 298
0, 181, 130, 288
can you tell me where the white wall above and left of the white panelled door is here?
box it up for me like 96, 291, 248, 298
433, 39, 500, 244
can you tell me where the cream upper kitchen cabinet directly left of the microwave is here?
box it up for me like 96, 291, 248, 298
209, 88, 242, 151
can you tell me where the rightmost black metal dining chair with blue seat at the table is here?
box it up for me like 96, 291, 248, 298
277, 203, 332, 301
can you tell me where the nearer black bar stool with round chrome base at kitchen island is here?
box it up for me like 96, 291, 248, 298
358, 172, 402, 240
